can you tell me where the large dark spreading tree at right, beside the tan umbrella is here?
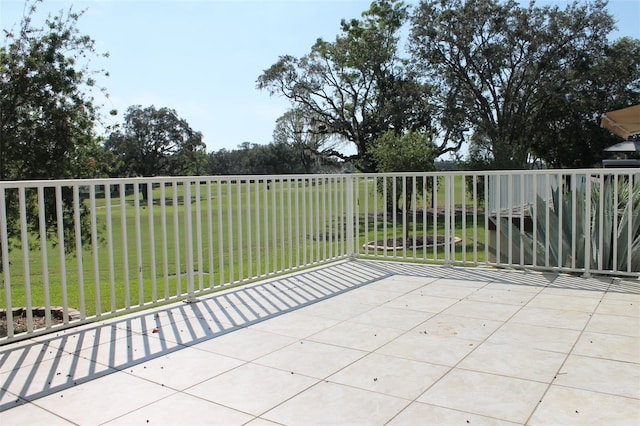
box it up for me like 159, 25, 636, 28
411, 0, 637, 168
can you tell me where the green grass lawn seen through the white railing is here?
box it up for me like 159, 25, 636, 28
0, 175, 484, 315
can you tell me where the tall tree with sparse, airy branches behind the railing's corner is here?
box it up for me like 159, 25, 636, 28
258, 0, 460, 171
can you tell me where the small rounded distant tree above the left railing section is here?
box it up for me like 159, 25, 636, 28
104, 105, 206, 181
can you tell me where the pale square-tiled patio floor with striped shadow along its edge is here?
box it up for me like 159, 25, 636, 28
0, 260, 640, 425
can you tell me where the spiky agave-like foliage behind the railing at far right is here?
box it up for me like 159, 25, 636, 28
491, 176, 640, 271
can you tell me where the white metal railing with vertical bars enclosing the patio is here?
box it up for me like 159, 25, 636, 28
0, 169, 640, 343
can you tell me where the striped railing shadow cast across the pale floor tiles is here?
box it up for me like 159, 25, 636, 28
0, 262, 393, 412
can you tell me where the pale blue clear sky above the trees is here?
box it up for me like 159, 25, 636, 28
0, 0, 640, 152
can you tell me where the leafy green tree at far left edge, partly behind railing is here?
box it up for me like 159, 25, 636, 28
0, 1, 106, 266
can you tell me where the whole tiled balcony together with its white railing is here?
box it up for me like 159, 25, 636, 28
0, 170, 640, 424
